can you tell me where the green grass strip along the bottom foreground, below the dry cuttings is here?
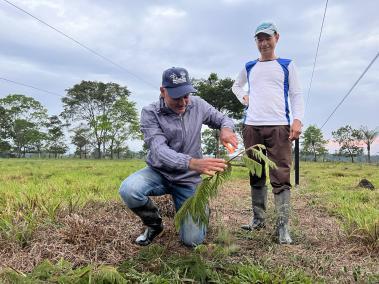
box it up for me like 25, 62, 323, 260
0, 244, 316, 284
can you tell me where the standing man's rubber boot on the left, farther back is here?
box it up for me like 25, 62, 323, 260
241, 186, 267, 231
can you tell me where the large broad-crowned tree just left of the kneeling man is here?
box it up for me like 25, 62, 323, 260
62, 81, 138, 158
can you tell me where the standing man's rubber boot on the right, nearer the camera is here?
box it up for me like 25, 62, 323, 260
274, 190, 292, 244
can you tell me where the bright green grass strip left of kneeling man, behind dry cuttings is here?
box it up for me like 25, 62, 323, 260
0, 159, 144, 202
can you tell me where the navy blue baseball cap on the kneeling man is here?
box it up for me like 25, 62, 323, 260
162, 67, 197, 99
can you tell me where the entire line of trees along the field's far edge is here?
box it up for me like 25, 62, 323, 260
0, 73, 379, 162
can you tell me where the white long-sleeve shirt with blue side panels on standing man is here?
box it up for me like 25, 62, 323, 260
232, 58, 304, 125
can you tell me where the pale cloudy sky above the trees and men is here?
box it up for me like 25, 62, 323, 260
0, 0, 379, 154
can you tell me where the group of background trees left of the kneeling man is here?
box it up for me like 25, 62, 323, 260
0, 81, 140, 158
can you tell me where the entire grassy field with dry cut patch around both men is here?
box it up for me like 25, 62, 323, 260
0, 160, 379, 283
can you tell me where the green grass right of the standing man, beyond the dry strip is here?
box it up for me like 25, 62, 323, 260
300, 162, 379, 247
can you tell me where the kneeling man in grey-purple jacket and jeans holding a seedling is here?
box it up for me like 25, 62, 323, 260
119, 67, 237, 246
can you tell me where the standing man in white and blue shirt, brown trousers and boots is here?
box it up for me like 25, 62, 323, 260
232, 22, 304, 244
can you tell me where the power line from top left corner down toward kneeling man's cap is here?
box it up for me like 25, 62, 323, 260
3, 0, 156, 89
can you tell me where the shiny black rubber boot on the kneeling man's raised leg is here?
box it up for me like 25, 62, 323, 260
130, 198, 163, 246
